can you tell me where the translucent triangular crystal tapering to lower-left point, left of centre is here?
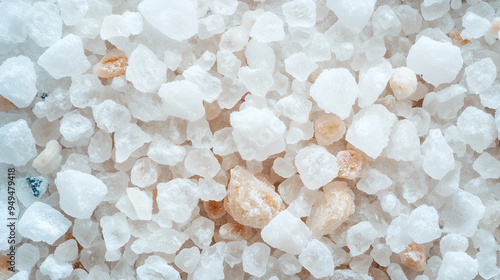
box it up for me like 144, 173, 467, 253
114, 123, 151, 163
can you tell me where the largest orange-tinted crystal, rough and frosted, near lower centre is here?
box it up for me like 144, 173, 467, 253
224, 166, 285, 228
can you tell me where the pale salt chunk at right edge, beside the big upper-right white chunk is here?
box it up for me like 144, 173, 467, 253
465, 57, 497, 93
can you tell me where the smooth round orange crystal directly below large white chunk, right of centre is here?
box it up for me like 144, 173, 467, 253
314, 114, 345, 146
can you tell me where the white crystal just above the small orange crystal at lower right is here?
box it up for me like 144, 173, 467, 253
408, 205, 441, 244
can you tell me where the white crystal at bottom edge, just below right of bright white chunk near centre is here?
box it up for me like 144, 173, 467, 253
299, 239, 335, 278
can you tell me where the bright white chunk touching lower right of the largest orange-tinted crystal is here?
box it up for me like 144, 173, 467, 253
261, 211, 312, 255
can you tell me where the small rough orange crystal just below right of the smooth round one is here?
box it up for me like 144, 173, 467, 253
337, 150, 365, 180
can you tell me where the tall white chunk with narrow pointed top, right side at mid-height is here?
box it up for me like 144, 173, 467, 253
422, 129, 455, 180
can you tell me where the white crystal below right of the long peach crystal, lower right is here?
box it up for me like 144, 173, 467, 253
346, 221, 377, 256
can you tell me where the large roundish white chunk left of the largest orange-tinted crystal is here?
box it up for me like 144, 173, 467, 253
156, 178, 198, 223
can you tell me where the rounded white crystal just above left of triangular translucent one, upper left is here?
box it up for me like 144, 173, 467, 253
92, 99, 132, 132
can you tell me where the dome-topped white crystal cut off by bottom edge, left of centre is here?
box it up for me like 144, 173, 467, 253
137, 255, 181, 280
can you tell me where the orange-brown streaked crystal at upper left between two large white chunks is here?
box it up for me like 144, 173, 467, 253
94, 49, 128, 79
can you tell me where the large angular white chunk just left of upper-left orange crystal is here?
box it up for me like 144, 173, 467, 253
38, 34, 90, 80
